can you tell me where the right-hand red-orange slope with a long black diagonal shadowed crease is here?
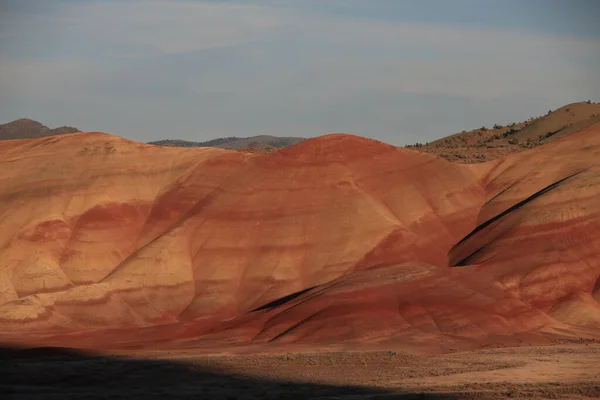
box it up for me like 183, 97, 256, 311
450, 124, 600, 326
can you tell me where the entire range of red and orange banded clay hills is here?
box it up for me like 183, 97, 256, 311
0, 124, 600, 348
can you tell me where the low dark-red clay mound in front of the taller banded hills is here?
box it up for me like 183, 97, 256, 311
204, 262, 562, 348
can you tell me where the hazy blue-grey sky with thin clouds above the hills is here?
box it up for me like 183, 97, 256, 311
0, 0, 600, 145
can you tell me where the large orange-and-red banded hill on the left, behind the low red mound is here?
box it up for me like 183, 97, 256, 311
0, 133, 485, 334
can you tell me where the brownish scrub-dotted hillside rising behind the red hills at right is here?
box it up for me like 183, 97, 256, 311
406, 101, 600, 164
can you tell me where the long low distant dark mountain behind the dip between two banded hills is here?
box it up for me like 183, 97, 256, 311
148, 135, 306, 150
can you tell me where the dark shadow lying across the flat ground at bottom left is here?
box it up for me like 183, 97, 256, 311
0, 348, 458, 400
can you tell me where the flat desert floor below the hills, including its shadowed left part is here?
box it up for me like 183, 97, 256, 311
0, 341, 600, 400
